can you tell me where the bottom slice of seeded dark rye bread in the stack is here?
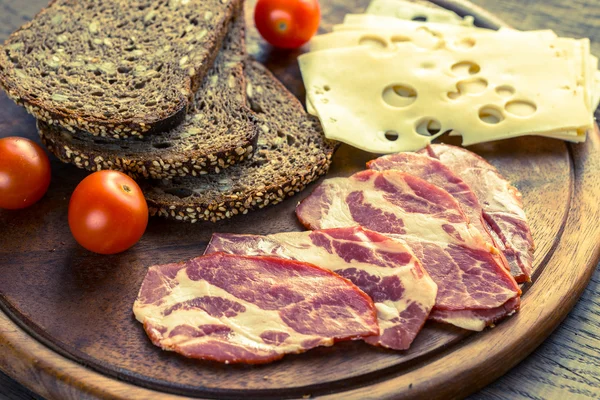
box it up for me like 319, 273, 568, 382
142, 61, 338, 223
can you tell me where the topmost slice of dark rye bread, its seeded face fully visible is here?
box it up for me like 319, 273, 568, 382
0, 0, 242, 138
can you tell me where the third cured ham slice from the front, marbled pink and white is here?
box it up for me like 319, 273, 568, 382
296, 170, 521, 330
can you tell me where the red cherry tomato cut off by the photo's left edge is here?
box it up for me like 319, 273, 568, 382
0, 137, 50, 210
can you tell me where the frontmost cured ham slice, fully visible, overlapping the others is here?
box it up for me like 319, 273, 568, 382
133, 253, 379, 364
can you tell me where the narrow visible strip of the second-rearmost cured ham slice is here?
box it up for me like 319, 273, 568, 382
367, 153, 527, 282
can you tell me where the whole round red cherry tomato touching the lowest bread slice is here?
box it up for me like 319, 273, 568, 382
69, 171, 148, 254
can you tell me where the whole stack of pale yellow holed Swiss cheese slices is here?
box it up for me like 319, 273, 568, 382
299, 0, 600, 153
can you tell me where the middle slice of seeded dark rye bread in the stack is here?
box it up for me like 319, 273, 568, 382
38, 16, 260, 179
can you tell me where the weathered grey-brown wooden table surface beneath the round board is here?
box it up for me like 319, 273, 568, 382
0, 0, 600, 400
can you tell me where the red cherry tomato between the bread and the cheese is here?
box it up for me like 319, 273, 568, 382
254, 0, 321, 49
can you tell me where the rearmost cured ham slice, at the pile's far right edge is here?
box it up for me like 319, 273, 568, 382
421, 144, 535, 282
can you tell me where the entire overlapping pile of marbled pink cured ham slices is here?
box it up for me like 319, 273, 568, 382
133, 144, 533, 363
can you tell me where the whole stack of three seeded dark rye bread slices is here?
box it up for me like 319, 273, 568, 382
0, 0, 336, 222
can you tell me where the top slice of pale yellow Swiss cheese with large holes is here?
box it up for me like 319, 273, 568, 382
299, 35, 593, 153
